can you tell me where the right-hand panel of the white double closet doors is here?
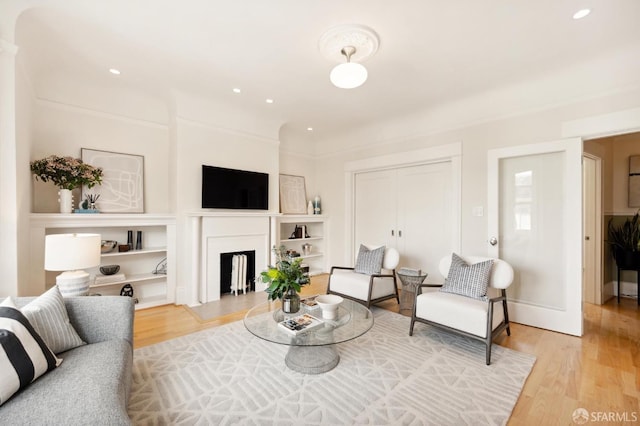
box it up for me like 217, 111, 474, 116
397, 162, 454, 283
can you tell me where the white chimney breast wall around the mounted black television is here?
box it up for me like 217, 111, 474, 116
170, 94, 280, 304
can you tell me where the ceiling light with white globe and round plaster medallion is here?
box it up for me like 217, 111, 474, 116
318, 25, 379, 89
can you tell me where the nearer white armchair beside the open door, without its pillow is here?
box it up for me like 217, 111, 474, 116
409, 256, 513, 365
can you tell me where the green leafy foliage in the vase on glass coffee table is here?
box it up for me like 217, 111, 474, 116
260, 246, 309, 300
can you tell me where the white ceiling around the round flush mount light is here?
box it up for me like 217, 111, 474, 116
3, 0, 640, 141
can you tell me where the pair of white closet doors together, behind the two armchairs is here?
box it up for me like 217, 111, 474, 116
354, 161, 457, 282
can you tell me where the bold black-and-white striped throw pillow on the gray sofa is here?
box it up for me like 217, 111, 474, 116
0, 305, 62, 405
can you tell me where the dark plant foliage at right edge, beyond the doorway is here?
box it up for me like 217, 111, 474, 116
608, 210, 640, 270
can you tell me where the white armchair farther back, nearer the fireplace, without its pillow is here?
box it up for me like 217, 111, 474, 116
327, 246, 400, 308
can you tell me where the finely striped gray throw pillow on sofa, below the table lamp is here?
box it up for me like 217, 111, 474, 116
20, 286, 85, 354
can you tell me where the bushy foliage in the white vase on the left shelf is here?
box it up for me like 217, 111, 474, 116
29, 155, 102, 189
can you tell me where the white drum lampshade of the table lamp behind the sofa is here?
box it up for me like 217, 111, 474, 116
44, 234, 101, 271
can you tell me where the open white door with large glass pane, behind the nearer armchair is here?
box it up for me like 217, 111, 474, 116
488, 139, 582, 336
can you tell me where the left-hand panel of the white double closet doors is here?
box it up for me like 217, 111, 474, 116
354, 170, 397, 259
